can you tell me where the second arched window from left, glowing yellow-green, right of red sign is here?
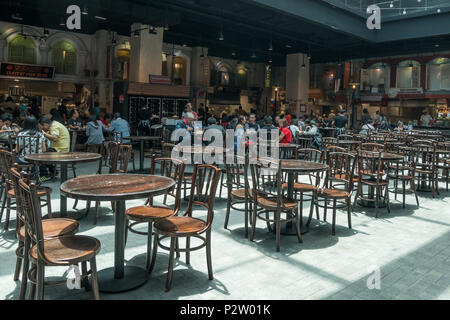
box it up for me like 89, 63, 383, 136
52, 41, 77, 74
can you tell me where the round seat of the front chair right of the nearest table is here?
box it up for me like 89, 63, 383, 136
155, 217, 206, 237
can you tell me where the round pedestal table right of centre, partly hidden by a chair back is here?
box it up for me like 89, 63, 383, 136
281, 160, 328, 235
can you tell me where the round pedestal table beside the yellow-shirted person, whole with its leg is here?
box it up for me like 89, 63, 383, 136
25, 152, 102, 217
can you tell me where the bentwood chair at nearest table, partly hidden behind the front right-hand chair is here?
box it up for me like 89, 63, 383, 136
125, 157, 184, 271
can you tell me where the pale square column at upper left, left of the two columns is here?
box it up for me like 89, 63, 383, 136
129, 23, 164, 83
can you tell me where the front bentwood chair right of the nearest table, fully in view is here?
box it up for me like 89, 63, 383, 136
150, 165, 220, 291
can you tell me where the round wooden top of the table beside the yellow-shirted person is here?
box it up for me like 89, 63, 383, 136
25, 152, 102, 164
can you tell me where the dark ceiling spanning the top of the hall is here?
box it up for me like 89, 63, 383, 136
0, 0, 450, 65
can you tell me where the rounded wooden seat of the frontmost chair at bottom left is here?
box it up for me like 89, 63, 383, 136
30, 236, 100, 265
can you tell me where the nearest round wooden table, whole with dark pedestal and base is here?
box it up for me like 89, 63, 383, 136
60, 174, 175, 293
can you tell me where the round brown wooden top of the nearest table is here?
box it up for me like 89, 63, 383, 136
60, 174, 175, 201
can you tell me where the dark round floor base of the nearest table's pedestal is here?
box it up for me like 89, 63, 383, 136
98, 266, 148, 293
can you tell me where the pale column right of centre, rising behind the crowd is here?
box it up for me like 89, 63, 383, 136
286, 53, 309, 114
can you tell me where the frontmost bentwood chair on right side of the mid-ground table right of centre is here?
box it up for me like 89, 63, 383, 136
307, 152, 356, 236
